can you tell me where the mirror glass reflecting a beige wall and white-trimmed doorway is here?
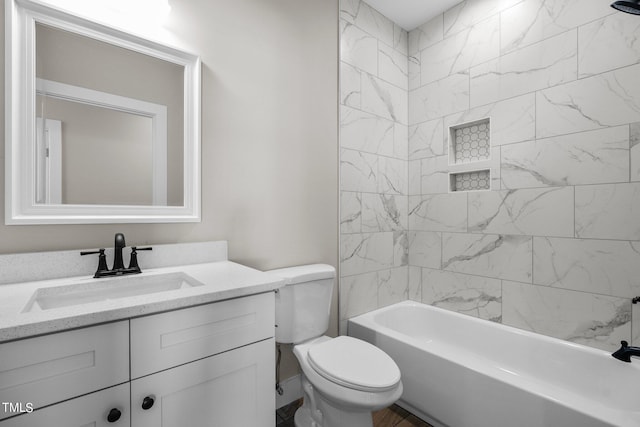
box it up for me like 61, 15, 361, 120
34, 23, 185, 206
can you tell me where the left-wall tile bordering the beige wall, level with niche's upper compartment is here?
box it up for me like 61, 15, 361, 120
340, 106, 395, 156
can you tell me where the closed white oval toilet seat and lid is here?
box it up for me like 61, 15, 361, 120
307, 336, 400, 393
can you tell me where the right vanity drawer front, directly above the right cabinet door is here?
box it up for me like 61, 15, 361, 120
131, 292, 275, 378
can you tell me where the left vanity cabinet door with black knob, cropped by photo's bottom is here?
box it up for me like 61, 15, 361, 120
0, 383, 130, 427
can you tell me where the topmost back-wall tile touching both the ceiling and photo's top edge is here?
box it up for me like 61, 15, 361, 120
444, 0, 522, 37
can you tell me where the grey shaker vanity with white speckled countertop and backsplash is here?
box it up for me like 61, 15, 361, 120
0, 242, 282, 427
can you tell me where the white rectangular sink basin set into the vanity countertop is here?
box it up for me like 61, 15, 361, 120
22, 272, 202, 313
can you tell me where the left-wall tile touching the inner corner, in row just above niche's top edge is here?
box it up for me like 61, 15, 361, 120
362, 74, 408, 124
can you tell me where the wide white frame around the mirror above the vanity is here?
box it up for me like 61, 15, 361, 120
5, 0, 201, 225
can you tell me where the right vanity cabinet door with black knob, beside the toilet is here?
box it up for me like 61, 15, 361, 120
131, 338, 275, 427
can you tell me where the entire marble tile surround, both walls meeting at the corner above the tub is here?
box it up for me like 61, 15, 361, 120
340, 0, 640, 350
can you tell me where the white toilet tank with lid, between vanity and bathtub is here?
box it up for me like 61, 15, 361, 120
267, 264, 336, 344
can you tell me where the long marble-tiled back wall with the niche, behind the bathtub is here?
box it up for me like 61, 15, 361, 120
406, 0, 640, 350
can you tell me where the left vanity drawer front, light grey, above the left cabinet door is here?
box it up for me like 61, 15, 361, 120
0, 321, 129, 419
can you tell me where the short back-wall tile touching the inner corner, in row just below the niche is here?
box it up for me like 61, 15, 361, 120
409, 193, 467, 232
